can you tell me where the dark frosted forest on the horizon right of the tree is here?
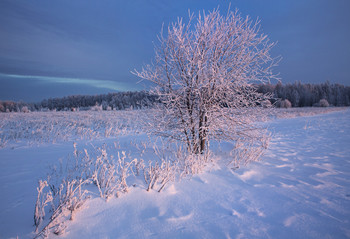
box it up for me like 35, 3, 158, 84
258, 82, 350, 107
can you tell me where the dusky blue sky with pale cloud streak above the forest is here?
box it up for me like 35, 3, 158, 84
0, 0, 350, 101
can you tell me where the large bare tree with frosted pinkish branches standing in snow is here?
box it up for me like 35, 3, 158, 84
133, 9, 279, 154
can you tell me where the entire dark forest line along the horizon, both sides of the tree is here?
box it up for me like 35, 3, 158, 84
0, 82, 350, 112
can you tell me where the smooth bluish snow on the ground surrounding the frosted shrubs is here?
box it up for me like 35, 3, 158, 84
0, 109, 350, 238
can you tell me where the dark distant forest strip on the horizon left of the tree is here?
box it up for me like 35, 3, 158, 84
0, 91, 157, 112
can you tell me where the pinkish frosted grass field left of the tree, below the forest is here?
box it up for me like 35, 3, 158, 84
0, 110, 147, 148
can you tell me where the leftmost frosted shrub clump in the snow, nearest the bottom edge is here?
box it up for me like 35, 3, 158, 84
34, 146, 92, 238
